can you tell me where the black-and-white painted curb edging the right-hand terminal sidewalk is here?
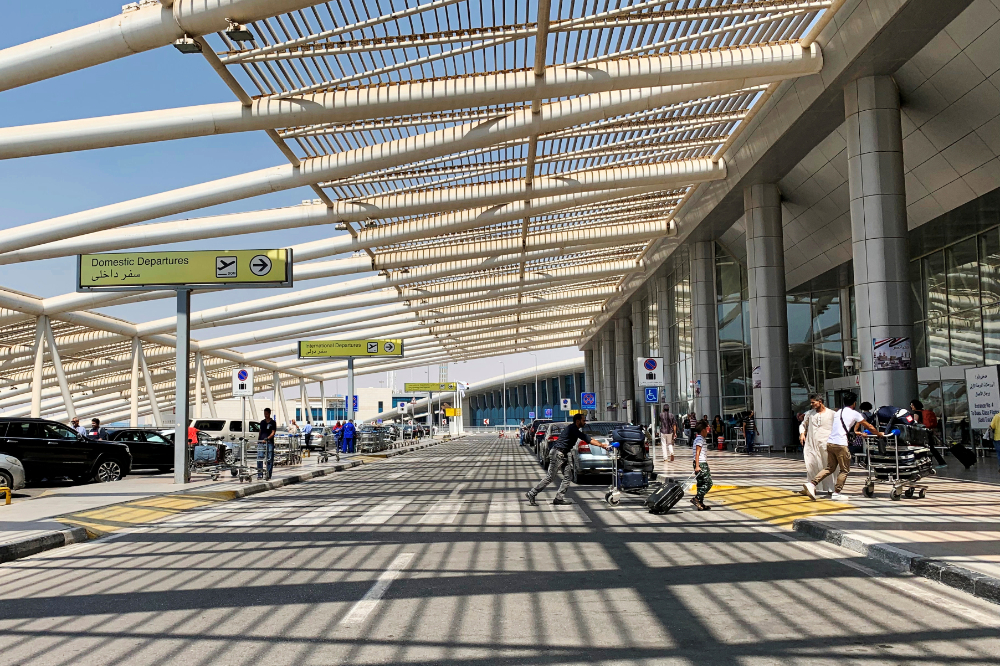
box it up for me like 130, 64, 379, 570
792, 519, 1000, 604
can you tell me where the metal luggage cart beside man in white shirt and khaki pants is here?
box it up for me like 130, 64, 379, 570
862, 435, 935, 501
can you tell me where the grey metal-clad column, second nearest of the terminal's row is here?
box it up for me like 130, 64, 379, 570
743, 183, 794, 450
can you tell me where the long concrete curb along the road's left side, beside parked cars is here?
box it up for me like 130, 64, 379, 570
0, 442, 441, 564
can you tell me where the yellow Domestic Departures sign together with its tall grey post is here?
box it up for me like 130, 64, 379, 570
76, 248, 292, 483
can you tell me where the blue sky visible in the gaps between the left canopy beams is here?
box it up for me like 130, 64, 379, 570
0, 0, 580, 390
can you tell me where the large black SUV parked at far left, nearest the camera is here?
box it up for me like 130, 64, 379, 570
0, 418, 132, 482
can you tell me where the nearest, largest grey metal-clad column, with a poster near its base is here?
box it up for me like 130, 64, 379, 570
844, 76, 917, 407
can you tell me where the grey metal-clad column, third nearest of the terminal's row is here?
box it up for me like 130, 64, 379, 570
691, 241, 722, 419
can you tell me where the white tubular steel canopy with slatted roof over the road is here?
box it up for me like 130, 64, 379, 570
0, 0, 828, 418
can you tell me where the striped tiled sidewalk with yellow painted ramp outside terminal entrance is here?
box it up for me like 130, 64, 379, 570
657, 449, 1000, 600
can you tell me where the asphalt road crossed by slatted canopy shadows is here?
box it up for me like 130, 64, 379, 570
0, 437, 1000, 666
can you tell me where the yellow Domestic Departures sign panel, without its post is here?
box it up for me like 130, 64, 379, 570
76, 248, 292, 291
